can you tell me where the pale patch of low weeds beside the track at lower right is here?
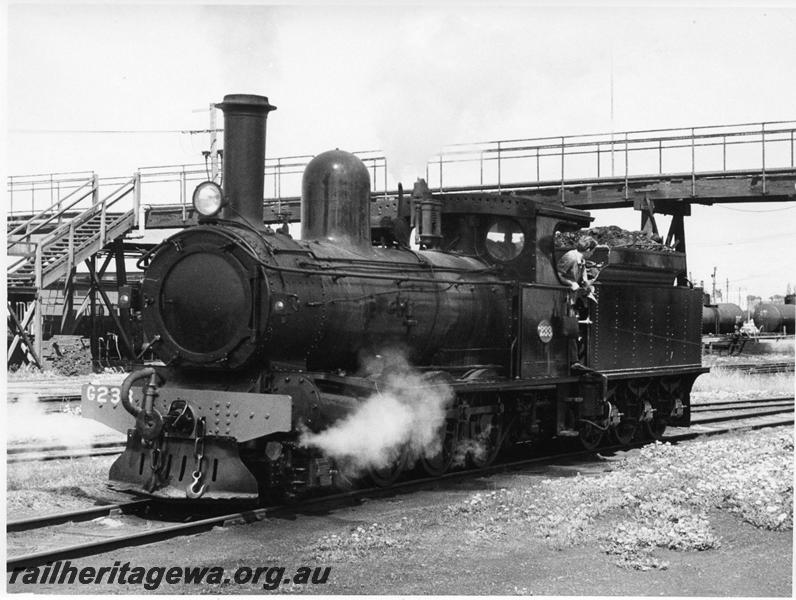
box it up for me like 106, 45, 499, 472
304, 430, 793, 570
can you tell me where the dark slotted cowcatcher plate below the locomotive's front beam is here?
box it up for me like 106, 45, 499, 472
110, 429, 258, 500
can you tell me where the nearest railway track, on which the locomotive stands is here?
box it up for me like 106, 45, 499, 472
6, 397, 793, 571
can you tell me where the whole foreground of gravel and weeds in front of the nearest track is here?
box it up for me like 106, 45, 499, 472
4, 428, 793, 597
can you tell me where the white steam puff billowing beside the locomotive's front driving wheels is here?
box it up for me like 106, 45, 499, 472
300, 352, 454, 471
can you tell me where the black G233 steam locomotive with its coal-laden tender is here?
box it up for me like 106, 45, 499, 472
83, 94, 707, 500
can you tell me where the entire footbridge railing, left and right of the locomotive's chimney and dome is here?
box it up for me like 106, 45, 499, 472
8, 120, 796, 218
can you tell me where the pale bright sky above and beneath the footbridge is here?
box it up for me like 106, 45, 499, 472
2, 2, 796, 302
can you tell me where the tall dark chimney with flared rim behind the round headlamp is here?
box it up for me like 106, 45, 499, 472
216, 94, 276, 228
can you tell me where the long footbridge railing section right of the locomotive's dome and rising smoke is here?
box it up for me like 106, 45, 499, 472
426, 121, 796, 195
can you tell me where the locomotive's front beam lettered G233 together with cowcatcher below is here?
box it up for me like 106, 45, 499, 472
82, 368, 292, 500
